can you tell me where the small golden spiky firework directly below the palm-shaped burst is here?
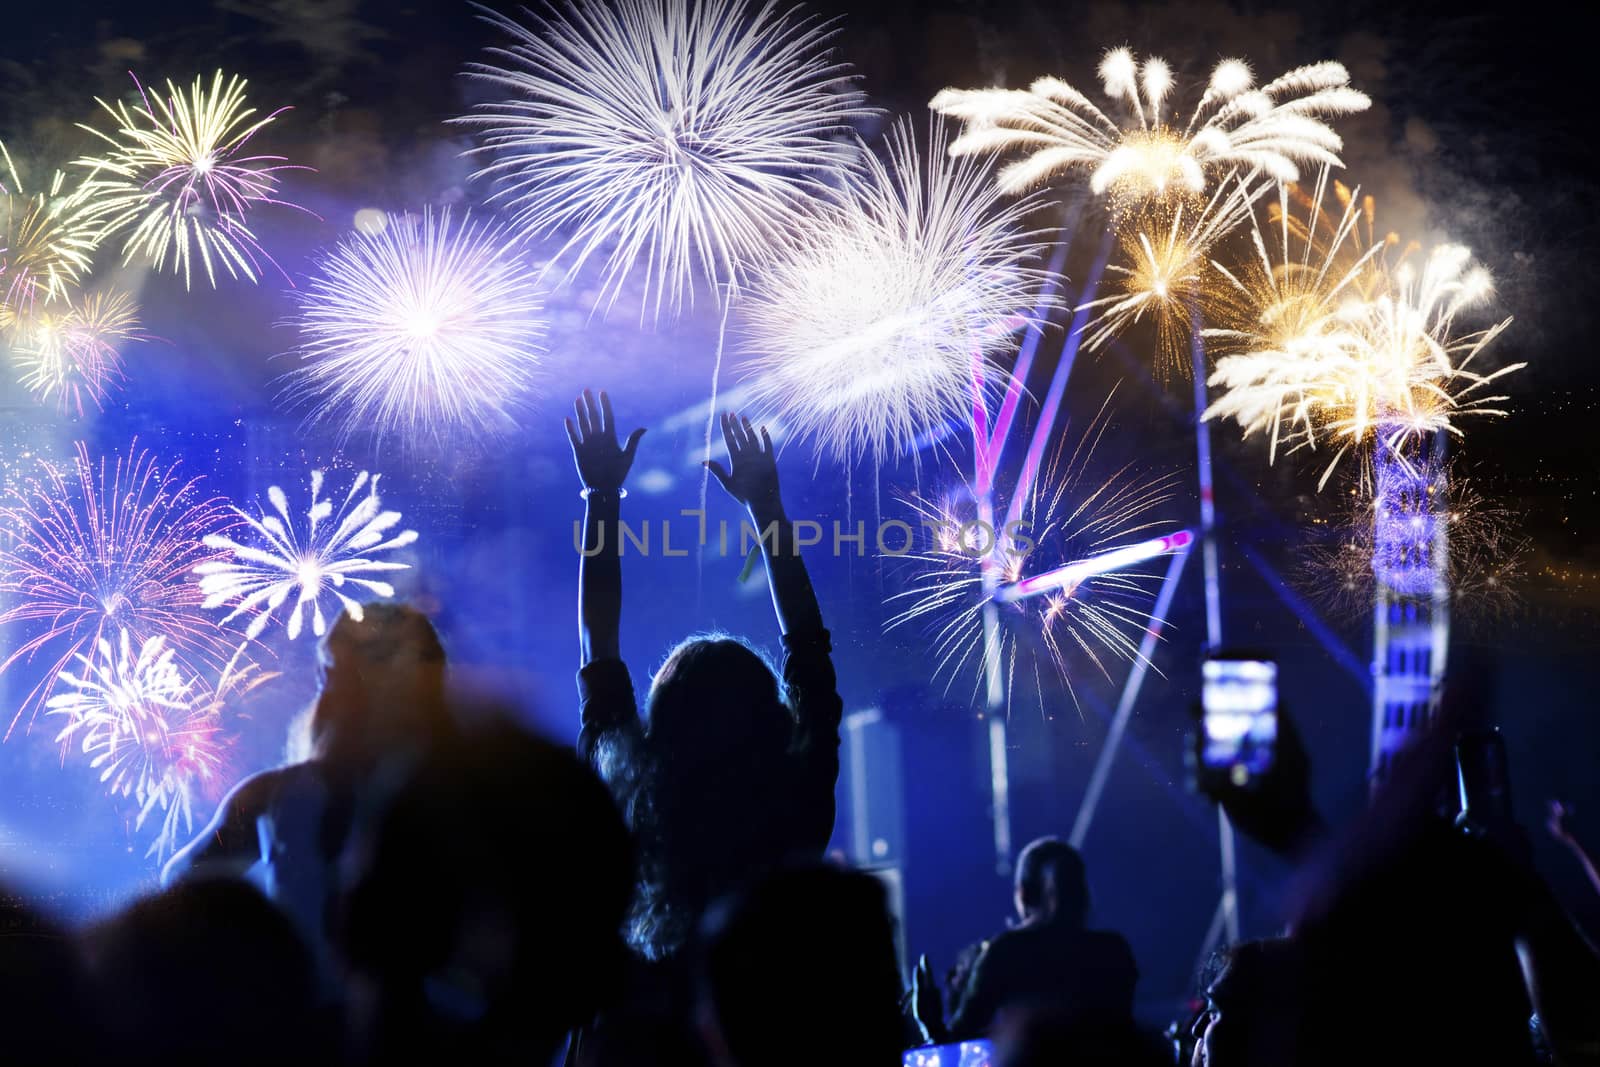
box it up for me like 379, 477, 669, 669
1082, 174, 1267, 373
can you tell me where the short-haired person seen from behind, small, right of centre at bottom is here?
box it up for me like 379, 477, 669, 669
918, 837, 1139, 1040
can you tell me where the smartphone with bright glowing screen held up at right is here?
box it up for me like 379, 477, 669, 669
1200, 656, 1278, 785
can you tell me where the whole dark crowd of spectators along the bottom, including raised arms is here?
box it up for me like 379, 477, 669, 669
0, 392, 1600, 1067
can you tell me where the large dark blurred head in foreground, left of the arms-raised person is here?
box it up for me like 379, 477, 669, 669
334, 713, 634, 1064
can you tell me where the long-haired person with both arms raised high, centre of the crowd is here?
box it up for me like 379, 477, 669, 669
566, 392, 842, 960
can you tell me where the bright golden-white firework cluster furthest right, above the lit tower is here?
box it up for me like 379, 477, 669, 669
1205, 220, 1526, 488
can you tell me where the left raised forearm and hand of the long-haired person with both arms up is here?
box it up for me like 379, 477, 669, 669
563, 389, 645, 665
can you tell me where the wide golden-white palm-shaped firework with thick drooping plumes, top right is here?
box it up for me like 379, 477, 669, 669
930, 48, 1371, 202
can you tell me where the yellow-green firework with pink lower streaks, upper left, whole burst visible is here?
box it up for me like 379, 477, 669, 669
75, 70, 302, 288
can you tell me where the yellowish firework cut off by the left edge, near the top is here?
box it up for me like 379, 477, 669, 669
0, 142, 94, 323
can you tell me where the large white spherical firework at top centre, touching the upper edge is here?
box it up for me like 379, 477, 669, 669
459, 0, 872, 317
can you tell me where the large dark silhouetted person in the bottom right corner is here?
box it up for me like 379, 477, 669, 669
1291, 700, 1574, 1067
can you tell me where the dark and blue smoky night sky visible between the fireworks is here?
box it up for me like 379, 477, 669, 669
0, 0, 1600, 1014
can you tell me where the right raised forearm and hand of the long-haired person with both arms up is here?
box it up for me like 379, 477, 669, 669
706, 414, 822, 637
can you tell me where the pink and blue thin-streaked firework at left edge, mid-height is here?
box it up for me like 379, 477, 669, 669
0, 442, 237, 739
